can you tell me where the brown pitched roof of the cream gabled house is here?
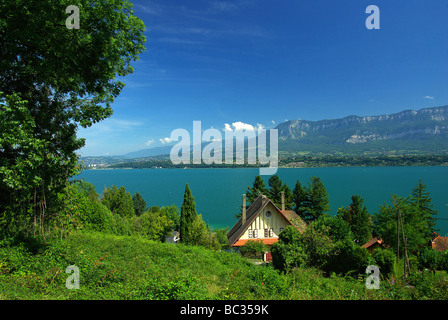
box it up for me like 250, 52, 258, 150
227, 195, 306, 247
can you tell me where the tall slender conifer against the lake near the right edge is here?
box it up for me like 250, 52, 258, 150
411, 179, 438, 238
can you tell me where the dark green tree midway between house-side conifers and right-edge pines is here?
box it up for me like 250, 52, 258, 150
338, 195, 372, 245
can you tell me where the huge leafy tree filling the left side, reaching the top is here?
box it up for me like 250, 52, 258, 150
0, 0, 145, 235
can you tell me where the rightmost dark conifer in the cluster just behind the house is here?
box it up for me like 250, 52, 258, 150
303, 177, 330, 222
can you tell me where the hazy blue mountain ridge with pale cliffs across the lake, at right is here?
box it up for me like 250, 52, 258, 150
276, 106, 448, 152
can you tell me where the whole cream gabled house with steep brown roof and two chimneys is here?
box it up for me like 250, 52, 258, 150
227, 194, 306, 247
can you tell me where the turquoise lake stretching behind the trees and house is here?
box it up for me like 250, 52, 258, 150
78, 167, 448, 235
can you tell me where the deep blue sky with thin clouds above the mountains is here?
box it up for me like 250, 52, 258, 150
78, 0, 448, 156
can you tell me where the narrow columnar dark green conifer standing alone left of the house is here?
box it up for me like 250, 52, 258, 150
180, 183, 198, 244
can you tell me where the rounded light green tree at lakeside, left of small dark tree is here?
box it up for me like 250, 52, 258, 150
101, 185, 135, 217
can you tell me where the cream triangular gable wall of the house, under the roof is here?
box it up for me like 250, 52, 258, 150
240, 203, 289, 240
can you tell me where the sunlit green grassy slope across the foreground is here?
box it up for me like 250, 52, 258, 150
0, 232, 448, 300
